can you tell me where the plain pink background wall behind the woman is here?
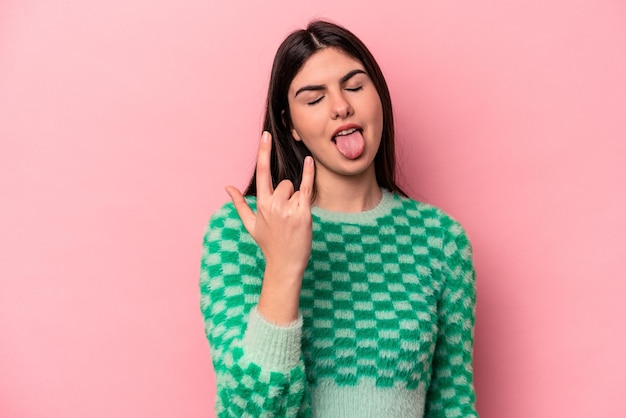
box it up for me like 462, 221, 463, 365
0, 0, 626, 418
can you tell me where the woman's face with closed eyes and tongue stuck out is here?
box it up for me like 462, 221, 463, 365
288, 47, 383, 183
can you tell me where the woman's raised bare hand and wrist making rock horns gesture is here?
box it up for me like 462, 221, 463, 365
226, 132, 315, 324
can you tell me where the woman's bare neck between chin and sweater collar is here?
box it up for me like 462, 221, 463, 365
313, 166, 382, 212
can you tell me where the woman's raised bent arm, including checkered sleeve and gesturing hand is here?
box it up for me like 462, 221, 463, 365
201, 132, 314, 417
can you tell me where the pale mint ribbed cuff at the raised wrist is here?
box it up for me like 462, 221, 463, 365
242, 308, 302, 372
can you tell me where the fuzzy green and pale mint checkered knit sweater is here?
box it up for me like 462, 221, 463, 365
200, 191, 478, 418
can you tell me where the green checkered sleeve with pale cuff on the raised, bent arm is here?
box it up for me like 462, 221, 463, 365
200, 204, 309, 417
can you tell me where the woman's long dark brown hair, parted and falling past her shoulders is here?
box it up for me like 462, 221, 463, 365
245, 20, 406, 196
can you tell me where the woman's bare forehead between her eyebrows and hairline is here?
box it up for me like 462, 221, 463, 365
289, 47, 365, 90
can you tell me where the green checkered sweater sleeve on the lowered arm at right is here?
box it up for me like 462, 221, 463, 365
425, 220, 478, 418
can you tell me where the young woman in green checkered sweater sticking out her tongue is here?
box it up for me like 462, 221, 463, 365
200, 21, 477, 418
